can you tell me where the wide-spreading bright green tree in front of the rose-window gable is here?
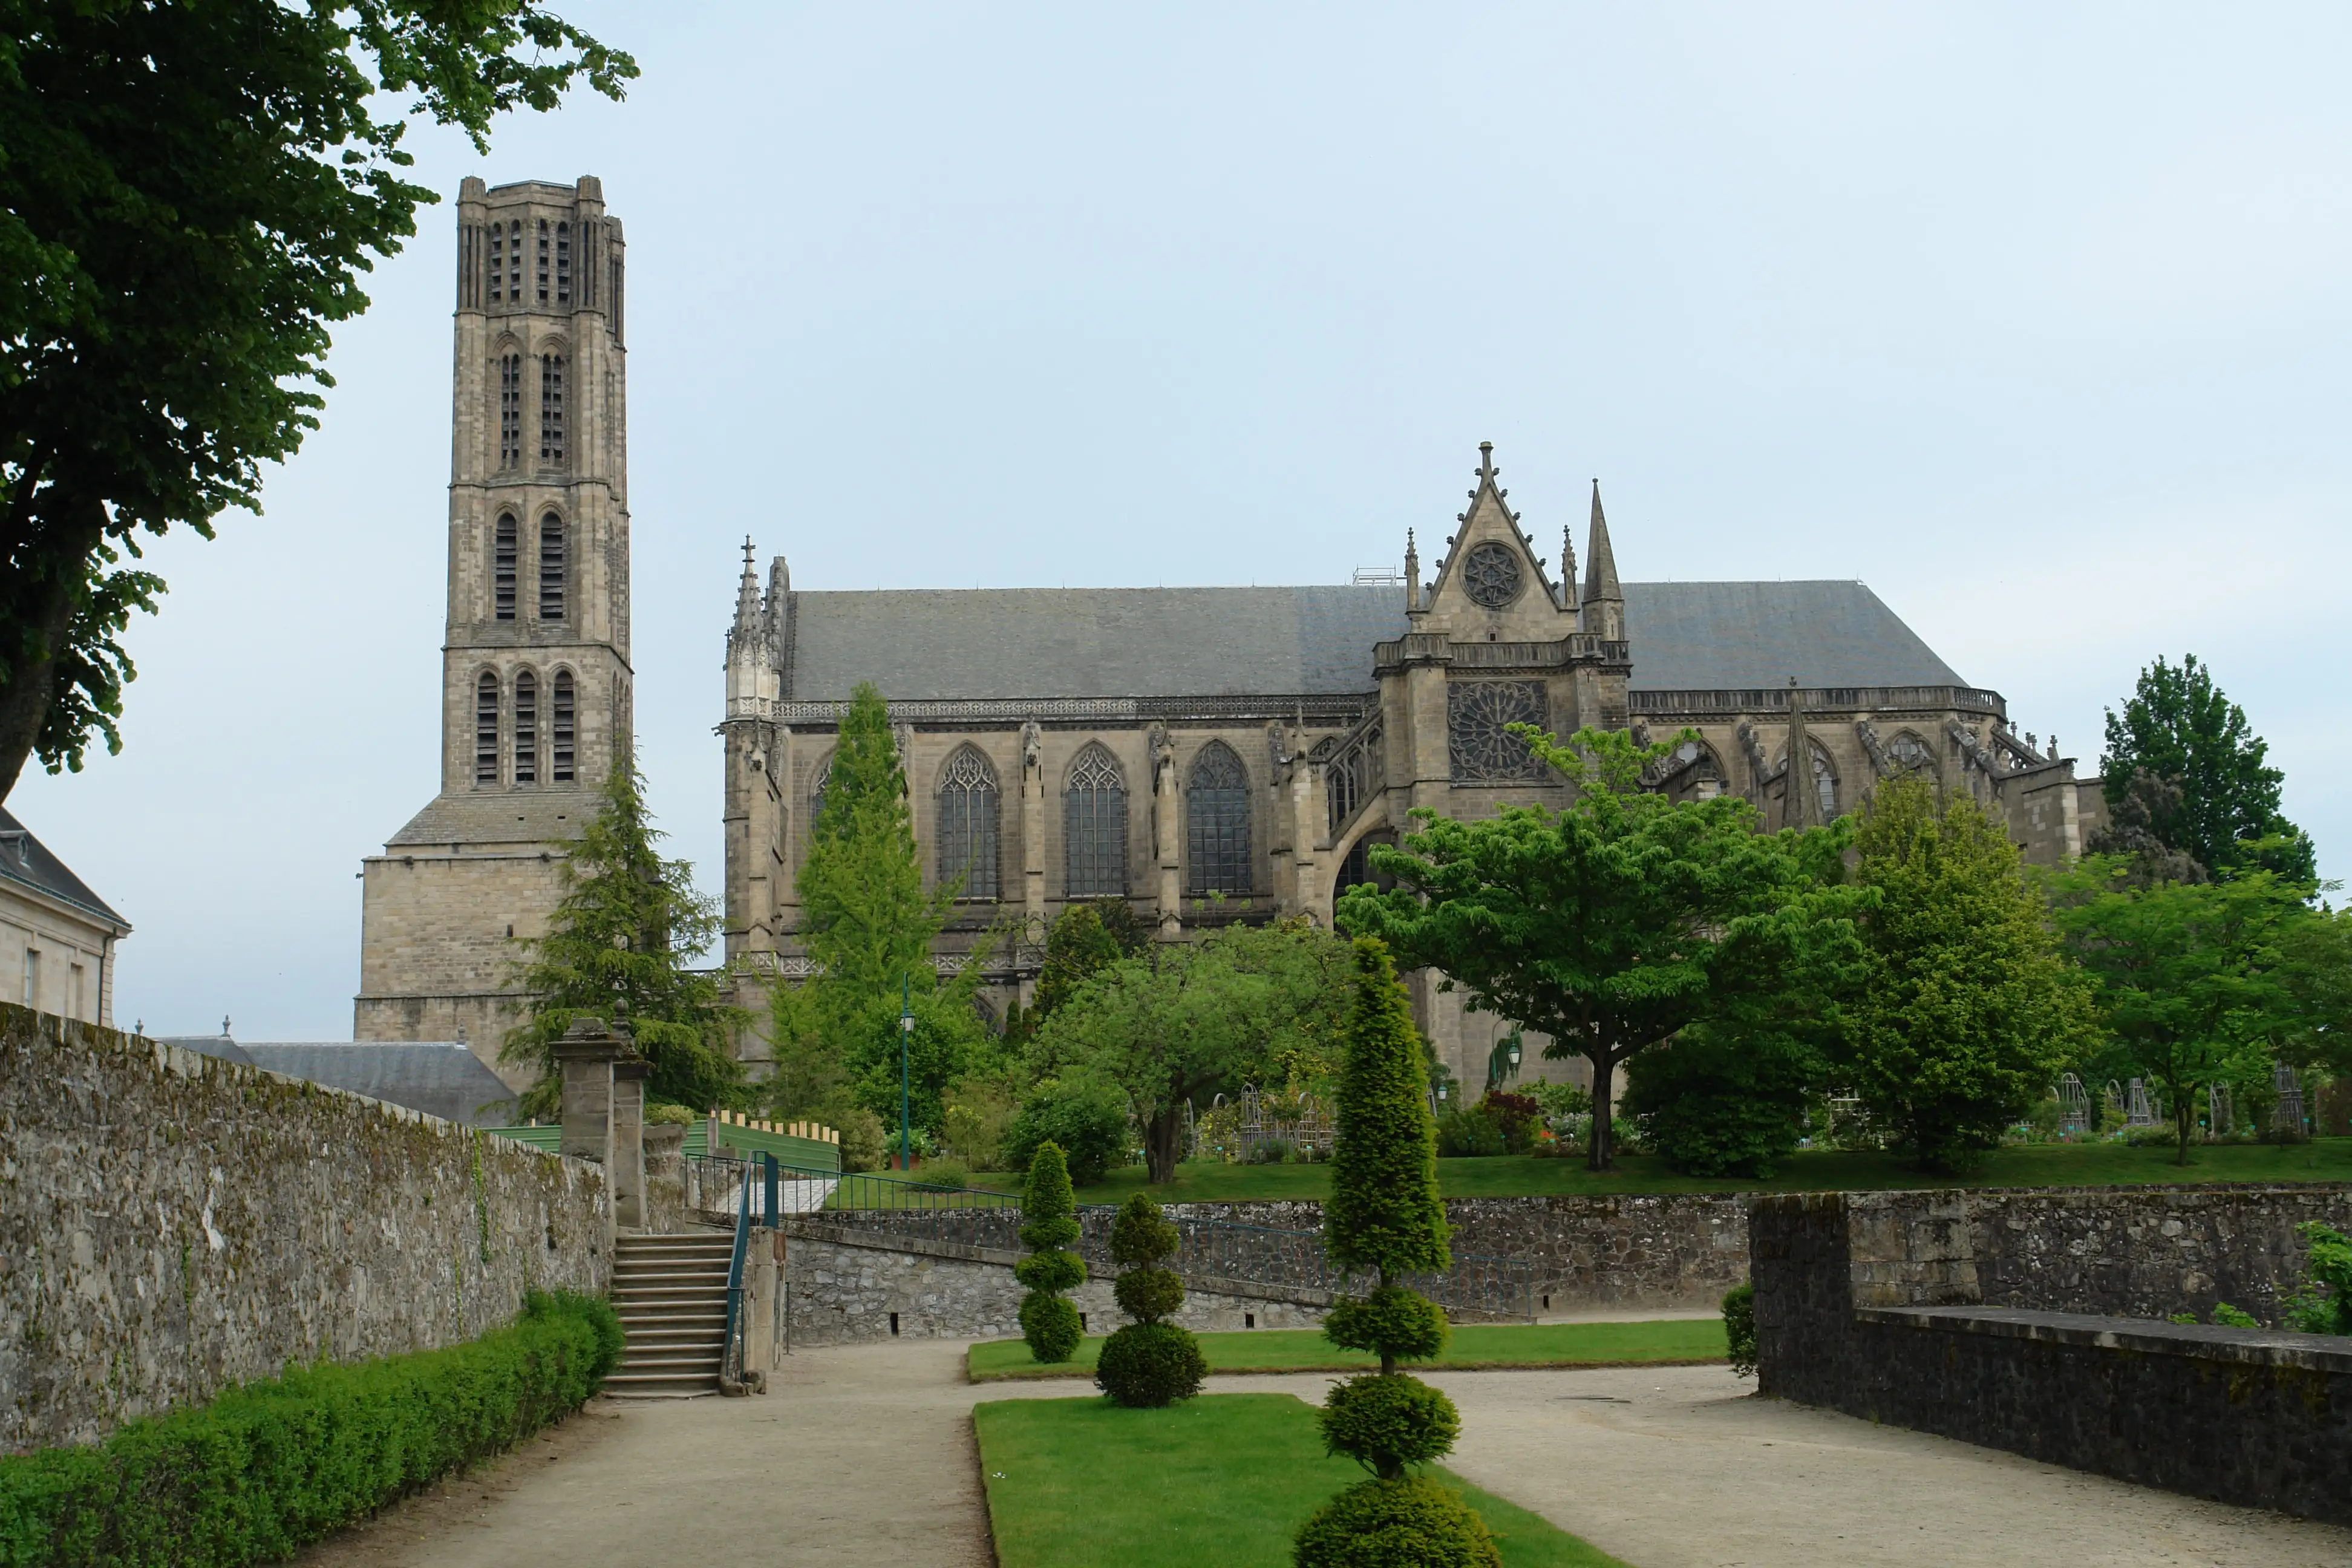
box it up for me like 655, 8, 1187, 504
1338, 724, 1856, 1171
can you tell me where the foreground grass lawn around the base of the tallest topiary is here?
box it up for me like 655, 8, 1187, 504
972, 1394, 1625, 1568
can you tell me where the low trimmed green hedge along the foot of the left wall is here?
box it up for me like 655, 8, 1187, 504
0, 1290, 626, 1568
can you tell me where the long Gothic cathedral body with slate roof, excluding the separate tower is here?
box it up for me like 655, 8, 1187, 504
720, 446, 2100, 1086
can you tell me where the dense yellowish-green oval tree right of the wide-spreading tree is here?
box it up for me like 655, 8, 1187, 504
1846, 778, 2091, 1171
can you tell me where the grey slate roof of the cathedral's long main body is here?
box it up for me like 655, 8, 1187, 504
780, 583, 1964, 701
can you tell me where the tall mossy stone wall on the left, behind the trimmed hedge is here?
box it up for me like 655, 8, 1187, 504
0, 1006, 612, 1453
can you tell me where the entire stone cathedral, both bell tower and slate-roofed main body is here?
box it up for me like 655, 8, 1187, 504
353, 178, 2103, 1105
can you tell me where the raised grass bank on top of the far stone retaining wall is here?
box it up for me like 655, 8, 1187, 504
950, 1138, 2352, 1204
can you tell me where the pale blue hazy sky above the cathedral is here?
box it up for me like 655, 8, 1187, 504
7, 2, 2352, 1039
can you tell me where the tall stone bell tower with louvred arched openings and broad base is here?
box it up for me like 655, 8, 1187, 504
353, 178, 630, 1077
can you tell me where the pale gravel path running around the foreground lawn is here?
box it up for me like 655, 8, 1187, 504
299, 1340, 2352, 1568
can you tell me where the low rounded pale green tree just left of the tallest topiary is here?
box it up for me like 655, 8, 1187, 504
1030, 921, 1348, 1183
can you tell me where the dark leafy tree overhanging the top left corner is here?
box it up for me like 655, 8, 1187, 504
0, 0, 638, 797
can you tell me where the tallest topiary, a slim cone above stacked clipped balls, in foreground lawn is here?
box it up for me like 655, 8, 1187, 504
1292, 936, 1501, 1568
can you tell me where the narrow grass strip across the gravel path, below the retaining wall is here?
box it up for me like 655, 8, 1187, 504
964, 1316, 1724, 1382
